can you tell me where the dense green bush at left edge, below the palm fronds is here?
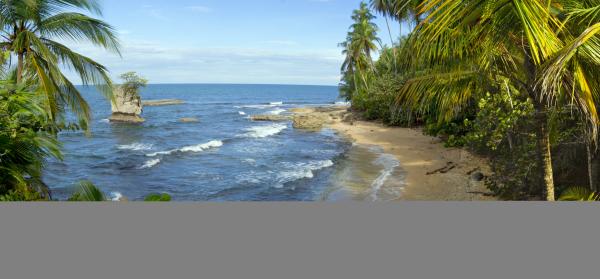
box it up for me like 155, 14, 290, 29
0, 82, 62, 200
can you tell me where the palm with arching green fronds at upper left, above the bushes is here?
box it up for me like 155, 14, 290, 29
0, 0, 119, 129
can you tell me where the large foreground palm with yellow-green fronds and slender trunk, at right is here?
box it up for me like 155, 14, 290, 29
399, 0, 600, 201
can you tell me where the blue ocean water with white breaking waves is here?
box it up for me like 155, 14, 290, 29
44, 84, 404, 201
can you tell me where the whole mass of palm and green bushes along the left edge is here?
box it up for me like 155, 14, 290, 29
0, 0, 119, 201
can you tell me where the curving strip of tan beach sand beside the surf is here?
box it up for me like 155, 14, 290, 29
294, 107, 495, 201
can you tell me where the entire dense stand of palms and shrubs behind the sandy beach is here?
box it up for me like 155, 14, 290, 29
340, 0, 600, 201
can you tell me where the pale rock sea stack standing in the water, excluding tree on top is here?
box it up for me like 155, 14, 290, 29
110, 86, 145, 123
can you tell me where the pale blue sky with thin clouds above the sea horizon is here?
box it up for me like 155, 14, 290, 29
67, 0, 400, 85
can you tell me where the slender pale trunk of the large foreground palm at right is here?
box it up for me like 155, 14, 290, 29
536, 105, 556, 201
